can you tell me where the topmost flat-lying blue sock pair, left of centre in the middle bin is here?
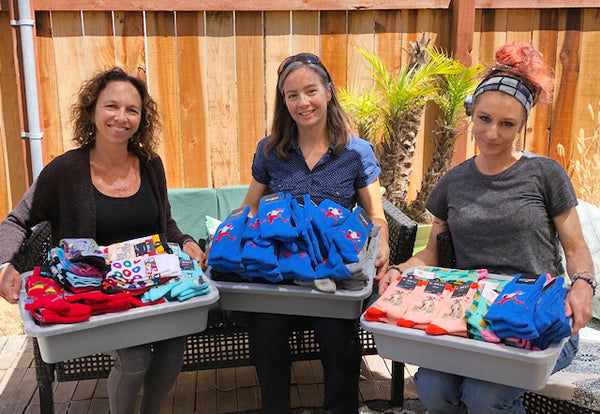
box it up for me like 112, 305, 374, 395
258, 192, 298, 241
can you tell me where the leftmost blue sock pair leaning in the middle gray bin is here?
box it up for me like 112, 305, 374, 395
208, 206, 250, 273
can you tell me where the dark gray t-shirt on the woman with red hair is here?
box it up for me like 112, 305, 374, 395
427, 152, 577, 275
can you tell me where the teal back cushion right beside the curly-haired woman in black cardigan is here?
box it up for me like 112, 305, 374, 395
168, 188, 218, 240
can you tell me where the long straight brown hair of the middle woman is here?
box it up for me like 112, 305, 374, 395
264, 61, 351, 159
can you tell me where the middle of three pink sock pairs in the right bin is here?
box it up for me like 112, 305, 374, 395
396, 280, 453, 329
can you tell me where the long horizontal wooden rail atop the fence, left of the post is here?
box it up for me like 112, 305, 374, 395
32, 0, 450, 11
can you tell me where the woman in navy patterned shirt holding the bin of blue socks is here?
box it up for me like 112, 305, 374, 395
243, 53, 389, 414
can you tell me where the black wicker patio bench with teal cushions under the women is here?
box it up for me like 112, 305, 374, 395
15, 186, 417, 414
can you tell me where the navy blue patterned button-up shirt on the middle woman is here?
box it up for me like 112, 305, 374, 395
252, 136, 381, 209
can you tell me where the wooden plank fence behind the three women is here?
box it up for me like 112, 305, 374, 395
0, 0, 600, 220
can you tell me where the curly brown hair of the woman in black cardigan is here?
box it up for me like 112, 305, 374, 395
72, 67, 160, 160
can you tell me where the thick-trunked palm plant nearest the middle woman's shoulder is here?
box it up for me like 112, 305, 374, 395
346, 36, 458, 210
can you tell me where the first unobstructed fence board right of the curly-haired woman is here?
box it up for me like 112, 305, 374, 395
177, 12, 212, 187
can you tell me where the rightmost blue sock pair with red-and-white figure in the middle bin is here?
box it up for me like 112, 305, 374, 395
330, 207, 373, 263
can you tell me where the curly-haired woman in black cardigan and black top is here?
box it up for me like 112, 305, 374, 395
0, 68, 204, 414
